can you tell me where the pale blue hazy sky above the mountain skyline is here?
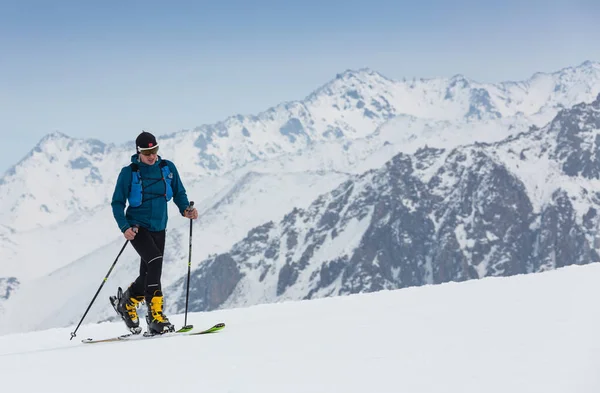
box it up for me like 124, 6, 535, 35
0, 0, 600, 174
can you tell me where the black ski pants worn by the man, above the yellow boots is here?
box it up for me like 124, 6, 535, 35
130, 228, 165, 304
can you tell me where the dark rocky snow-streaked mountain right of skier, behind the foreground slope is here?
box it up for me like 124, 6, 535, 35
168, 96, 600, 311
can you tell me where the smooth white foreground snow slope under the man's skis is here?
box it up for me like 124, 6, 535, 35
0, 264, 600, 393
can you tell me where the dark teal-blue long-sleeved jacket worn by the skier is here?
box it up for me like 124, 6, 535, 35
111, 154, 189, 232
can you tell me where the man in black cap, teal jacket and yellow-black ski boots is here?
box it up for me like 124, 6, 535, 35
111, 131, 198, 334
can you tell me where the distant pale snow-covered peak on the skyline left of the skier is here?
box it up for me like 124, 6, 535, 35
0, 136, 129, 231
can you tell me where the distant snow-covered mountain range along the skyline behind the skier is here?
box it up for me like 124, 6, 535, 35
0, 62, 600, 231
